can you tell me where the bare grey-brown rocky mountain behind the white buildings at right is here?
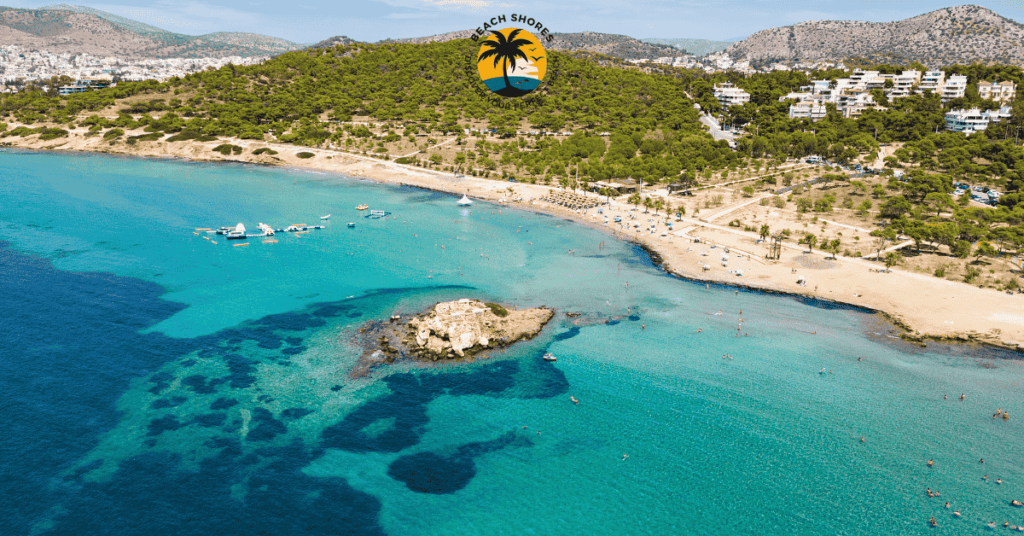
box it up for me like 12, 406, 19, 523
725, 5, 1024, 68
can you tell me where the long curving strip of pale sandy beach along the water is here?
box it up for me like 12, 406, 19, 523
8, 124, 1024, 349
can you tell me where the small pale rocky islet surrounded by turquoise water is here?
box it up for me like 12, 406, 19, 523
350, 298, 555, 377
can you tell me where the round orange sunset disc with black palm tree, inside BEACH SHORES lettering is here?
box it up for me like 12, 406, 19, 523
476, 28, 548, 96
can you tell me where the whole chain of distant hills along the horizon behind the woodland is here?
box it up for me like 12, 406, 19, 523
8, 4, 1024, 67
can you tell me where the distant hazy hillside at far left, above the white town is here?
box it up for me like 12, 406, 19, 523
0, 4, 303, 58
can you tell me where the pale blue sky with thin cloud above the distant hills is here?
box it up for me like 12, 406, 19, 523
12, 0, 1024, 43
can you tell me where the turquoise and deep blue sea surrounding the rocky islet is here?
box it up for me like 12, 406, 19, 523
0, 150, 1024, 536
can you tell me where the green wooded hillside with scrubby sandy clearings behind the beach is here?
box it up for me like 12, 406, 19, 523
0, 40, 1024, 348
